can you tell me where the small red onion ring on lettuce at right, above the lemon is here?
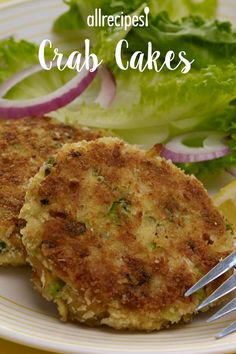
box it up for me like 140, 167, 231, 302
161, 131, 230, 163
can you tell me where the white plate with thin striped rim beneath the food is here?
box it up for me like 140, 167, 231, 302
0, 0, 236, 354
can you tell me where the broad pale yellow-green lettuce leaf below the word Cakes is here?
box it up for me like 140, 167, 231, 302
50, 64, 236, 130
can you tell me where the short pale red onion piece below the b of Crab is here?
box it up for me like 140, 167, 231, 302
94, 66, 116, 108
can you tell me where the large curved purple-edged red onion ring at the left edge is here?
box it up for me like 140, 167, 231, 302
0, 67, 97, 119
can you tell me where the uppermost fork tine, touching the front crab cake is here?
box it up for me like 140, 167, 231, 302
185, 252, 236, 296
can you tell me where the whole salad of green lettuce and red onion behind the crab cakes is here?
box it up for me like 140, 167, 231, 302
0, 0, 236, 178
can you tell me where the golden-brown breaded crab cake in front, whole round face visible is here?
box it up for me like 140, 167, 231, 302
20, 138, 233, 331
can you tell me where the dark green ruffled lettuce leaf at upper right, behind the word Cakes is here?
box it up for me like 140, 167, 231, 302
127, 13, 236, 68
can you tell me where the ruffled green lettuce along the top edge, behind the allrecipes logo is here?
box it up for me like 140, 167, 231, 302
54, 0, 236, 68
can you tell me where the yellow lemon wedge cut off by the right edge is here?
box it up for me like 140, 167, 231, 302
213, 181, 236, 229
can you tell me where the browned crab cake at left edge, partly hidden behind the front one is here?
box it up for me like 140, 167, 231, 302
0, 118, 105, 265
